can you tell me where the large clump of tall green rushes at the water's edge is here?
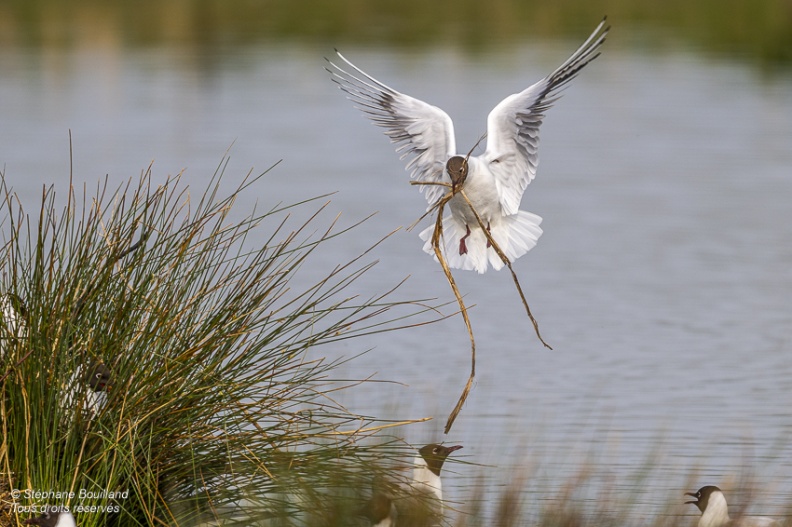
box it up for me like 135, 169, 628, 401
0, 165, 436, 527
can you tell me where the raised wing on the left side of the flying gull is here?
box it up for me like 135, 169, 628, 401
326, 50, 456, 207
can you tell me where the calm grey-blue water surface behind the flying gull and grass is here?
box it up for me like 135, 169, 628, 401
0, 36, 792, 514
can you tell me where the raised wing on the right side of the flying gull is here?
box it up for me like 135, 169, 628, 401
482, 18, 610, 215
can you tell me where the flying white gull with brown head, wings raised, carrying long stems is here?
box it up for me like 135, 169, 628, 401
328, 19, 610, 273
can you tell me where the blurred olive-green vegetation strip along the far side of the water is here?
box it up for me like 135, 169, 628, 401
0, 0, 792, 70
